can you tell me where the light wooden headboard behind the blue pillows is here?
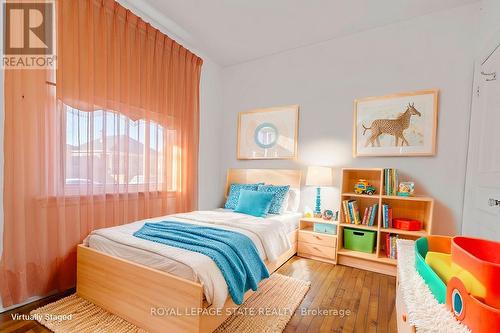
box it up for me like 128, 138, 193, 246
224, 169, 302, 197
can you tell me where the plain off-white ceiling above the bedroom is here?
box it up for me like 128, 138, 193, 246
139, 0, 478, 66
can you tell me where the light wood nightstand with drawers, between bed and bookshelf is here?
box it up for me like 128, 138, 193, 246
297, 217, 338, 264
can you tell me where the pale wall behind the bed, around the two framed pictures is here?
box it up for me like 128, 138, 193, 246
223, 4, 479, 234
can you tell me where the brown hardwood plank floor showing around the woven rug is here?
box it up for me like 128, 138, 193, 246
0, 257, 397, 333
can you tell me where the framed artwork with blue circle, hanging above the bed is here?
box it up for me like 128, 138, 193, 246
237, 105, 299, 160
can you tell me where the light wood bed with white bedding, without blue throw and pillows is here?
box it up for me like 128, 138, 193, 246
77, 169, 301, 332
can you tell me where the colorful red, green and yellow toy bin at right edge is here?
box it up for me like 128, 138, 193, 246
415, 236, 500, 333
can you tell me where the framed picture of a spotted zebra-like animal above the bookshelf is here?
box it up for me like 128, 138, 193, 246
353, 89, 439, 157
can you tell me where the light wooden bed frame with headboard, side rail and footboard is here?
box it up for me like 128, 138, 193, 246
76, 169, 301, 333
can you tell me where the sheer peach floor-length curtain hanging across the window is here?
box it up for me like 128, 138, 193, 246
0, 0, 202, 306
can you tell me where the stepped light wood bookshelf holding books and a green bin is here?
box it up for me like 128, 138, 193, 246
337, 168, 434, 276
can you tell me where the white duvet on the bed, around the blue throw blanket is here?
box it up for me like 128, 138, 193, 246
84, 210, 291, 307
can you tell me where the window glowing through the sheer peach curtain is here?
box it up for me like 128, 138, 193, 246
63, 105, 179, 192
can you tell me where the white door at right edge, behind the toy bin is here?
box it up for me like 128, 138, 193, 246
457, 38, 500, 241
